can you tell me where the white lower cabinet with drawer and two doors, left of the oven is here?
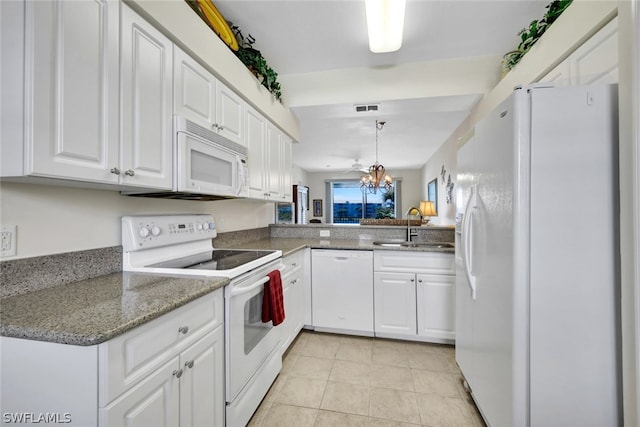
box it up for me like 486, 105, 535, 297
0, 289, 225, 427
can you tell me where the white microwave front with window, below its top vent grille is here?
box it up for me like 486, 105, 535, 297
176, 132, 247, 197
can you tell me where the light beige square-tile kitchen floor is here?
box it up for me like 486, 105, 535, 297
249, 331, 485, 427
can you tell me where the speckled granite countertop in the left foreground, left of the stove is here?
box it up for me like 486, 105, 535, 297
0, 273, 229, 346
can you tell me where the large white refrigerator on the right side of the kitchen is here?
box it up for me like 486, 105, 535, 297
456, 85, 622, 427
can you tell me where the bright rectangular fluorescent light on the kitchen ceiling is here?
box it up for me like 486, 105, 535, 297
365, 0, 406, 53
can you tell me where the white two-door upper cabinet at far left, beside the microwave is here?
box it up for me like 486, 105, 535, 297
1, 0, 172, 189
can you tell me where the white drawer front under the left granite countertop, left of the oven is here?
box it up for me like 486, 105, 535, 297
98, 289, 224, 406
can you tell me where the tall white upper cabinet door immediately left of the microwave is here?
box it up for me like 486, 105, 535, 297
120, 4, 173, 189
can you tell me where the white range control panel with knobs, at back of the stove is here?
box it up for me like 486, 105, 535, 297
122, 214, 218, 252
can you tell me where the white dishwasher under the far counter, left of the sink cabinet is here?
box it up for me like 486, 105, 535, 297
311, 249, 373, 336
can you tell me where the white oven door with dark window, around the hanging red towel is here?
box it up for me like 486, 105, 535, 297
224, 262, 281, 402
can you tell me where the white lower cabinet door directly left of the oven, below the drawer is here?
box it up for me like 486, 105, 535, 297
180, 327, 225, 427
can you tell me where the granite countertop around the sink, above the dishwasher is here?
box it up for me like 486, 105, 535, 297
214, 237, 455, 256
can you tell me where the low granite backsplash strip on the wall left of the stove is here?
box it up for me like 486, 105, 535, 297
0, 246, 122, 298
